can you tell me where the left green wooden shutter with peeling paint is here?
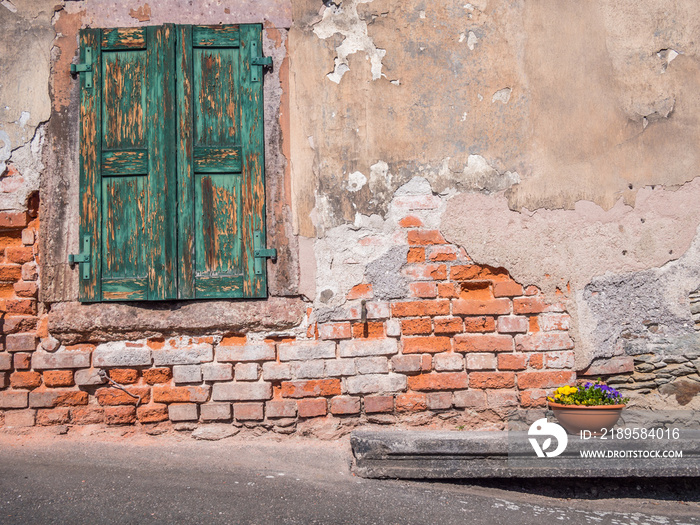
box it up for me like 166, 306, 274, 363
80, 26, 177, 301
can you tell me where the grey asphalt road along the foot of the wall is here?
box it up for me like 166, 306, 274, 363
0, 426, 700, 525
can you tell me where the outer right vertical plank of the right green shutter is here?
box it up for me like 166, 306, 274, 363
239, 24, 267, 297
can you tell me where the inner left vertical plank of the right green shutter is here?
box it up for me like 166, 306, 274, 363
175, 26, 195, 299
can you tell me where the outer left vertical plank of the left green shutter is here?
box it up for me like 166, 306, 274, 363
78, 29, 102, 301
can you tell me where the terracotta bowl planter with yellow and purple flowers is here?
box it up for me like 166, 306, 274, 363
547, 379, 629, 436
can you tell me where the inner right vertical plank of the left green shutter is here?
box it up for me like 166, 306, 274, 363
146, 24, 177, 300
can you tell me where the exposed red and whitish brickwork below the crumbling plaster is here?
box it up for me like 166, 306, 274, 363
0, 201, 576, 433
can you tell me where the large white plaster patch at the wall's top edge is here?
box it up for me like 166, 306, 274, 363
314, 0, 386, 84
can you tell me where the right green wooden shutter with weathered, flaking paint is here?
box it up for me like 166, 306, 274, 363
177, 25, 267, 299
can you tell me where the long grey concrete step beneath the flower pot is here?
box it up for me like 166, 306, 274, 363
351, 430, 700, 479
